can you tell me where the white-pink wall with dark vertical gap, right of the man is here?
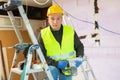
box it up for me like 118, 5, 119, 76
53, 0, 120, 80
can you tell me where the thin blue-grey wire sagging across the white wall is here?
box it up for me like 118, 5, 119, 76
53, 0, 120, 36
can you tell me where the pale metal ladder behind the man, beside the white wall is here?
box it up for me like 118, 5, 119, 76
63, 13, 97, 80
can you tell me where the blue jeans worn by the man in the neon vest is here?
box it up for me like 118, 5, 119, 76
46, 66, 72, 80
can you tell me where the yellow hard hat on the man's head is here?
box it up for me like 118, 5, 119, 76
47, 5, 64, 16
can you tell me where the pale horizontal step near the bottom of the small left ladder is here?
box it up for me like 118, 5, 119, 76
11, 68, 44, 74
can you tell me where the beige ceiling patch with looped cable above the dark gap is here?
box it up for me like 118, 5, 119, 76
0, 0, 52, 8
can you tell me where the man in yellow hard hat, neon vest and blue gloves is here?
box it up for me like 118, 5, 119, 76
38, 5, 84, 80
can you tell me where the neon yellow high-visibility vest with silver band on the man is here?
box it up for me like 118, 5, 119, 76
41, 26, 75, 61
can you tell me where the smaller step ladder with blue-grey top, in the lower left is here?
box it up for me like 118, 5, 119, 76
9, 43, 44, 80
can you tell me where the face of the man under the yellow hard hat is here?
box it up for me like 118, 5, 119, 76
48, 14, 62, 31
